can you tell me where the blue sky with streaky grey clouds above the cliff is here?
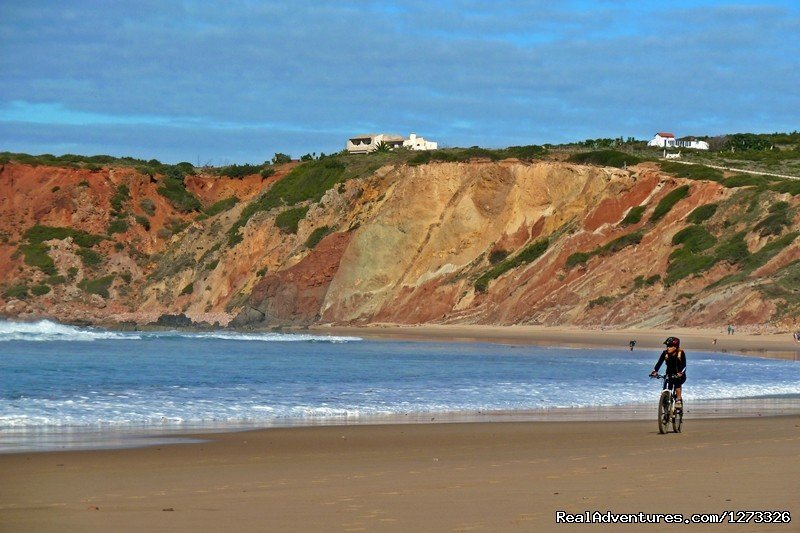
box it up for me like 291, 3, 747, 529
0, 0, 800, 166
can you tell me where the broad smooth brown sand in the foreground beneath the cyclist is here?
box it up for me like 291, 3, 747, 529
0, 416, 800, 532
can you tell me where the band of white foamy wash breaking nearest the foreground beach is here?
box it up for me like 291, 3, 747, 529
0, 383, 800, 431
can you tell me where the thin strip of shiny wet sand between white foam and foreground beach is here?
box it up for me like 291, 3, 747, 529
6, 392, 800, 456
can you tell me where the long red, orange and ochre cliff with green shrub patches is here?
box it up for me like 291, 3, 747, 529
0, 156, 800, 328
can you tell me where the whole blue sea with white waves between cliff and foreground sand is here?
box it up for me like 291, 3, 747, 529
0, 321, 800, 453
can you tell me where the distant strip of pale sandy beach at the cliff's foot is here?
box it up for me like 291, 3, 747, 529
312, 324, 800, 361
